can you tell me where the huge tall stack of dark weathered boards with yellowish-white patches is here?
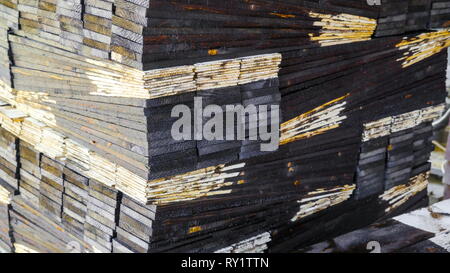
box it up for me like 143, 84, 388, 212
0, 0, 450, 253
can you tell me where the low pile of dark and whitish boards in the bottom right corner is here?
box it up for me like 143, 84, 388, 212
298, 198, 450, 253
